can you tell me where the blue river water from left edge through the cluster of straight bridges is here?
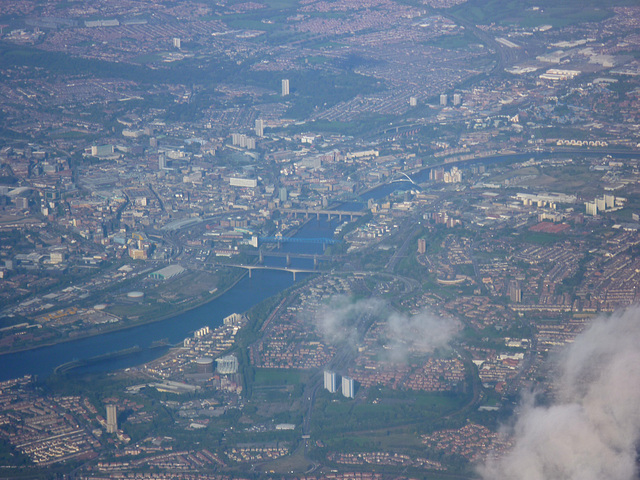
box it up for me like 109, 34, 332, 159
0, 219, 336, 380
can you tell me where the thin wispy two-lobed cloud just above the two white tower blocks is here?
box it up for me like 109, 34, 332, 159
316, 296, 460, 362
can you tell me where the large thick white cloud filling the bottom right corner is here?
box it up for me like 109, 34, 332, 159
481, 307, 640, 480
